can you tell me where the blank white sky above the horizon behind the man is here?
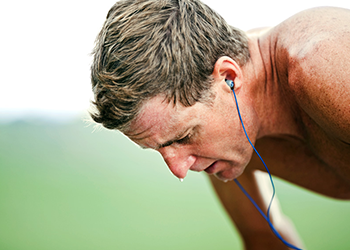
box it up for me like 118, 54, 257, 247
0, 0, 350, 122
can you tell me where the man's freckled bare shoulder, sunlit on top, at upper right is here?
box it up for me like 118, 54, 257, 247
275, 8, 350, 143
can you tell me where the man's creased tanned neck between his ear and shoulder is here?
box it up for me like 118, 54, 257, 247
245, 29, 300, 139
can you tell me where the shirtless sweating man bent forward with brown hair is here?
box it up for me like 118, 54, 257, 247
92, 0, 350, 249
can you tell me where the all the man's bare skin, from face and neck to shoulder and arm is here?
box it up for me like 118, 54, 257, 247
126, 8, 350, 249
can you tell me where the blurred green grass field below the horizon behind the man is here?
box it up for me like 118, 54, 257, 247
0, 117, 350, 250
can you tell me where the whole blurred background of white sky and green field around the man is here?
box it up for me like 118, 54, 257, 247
0, 0, 350, 250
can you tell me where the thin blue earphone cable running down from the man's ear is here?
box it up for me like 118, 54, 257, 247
226, 80, 302, 250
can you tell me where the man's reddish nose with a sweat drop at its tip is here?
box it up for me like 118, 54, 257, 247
158, 146, 196, 179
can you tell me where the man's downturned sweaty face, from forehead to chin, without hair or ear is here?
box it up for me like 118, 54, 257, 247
126, 80, 256, 180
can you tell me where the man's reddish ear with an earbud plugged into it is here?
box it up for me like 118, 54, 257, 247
212, 56, 243, 92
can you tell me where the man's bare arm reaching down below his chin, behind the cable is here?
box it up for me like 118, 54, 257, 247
210, 170, 301, 250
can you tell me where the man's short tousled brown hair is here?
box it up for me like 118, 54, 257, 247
91, 0, 249, 131
